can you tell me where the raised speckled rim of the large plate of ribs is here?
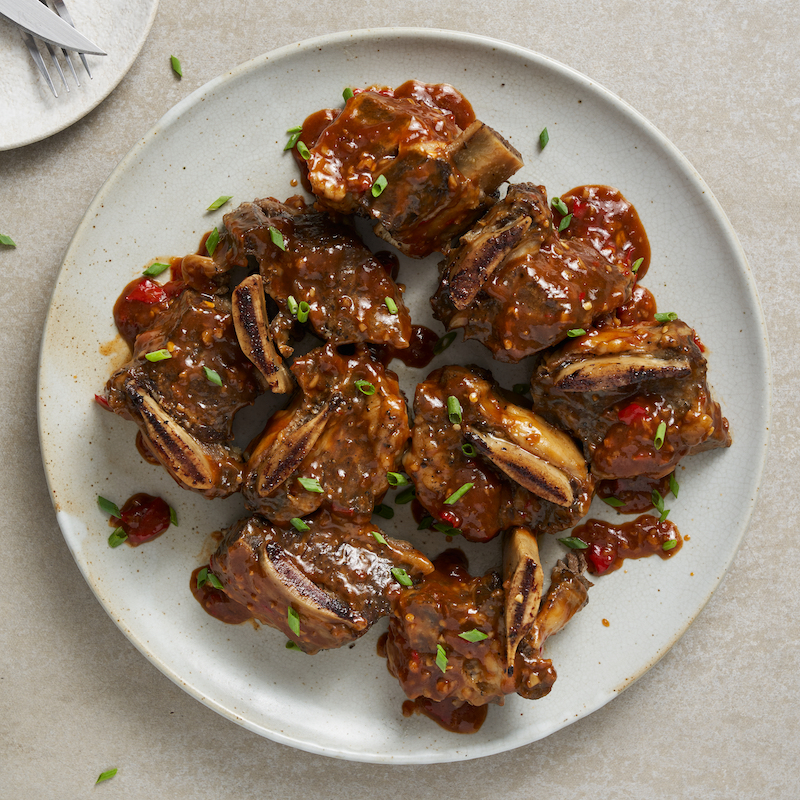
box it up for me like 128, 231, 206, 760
39, 28, 771, 764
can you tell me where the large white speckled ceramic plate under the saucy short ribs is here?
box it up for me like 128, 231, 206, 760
39, 29, 769, 763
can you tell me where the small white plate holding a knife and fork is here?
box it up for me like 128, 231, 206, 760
0, 0, 158, 150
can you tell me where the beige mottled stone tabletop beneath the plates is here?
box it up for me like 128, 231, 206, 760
0, 0, 800, 800
